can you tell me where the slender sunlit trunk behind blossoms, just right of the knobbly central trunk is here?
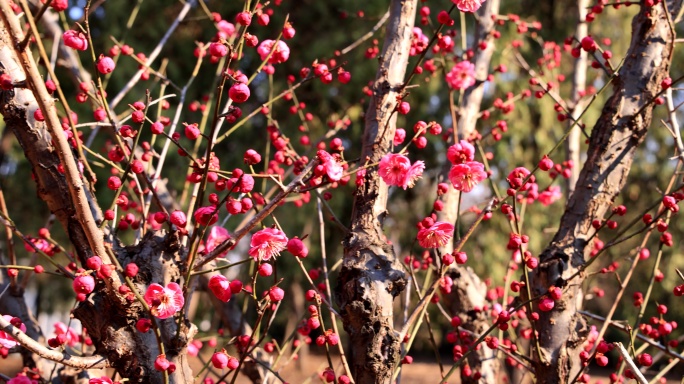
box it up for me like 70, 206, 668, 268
437, 0, 499, 383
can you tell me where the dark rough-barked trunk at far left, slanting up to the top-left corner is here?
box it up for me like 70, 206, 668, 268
0, 13, 195, 383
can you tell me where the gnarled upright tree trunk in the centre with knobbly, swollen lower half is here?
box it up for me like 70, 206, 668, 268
337, 0, 417, 383
